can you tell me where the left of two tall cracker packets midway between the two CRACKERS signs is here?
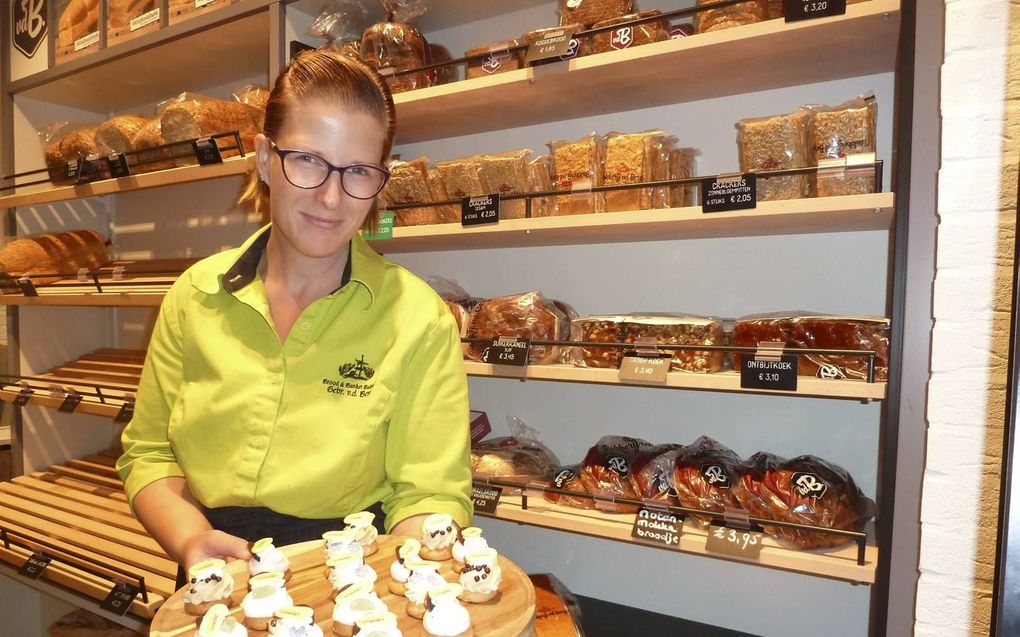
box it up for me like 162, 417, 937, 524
549, 132, 605, 215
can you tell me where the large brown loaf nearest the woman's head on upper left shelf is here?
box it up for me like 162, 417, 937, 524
159, 99, 259, 157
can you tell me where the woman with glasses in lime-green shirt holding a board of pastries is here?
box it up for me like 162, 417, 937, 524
117, 51, 471, 568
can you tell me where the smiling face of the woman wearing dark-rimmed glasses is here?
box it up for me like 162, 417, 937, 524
255, 100, 386, 259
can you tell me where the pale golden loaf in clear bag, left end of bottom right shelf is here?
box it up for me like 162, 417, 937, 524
471, 417, 560, 484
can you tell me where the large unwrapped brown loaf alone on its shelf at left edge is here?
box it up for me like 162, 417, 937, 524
0, 229, 110, 285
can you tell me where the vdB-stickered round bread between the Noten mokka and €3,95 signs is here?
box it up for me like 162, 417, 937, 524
673, 436, 741, 526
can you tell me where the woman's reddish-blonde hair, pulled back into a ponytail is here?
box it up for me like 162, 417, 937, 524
238, 50, 397, 231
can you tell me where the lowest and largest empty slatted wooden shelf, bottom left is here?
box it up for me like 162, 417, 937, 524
0, 452, 176, 619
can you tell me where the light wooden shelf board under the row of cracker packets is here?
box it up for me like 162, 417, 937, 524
371, 191, 896, 253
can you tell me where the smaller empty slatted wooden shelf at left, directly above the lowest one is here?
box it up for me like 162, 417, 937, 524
0, 349, 145, 417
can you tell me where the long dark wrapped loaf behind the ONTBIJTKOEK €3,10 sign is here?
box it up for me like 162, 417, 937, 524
733, 313, 889, 380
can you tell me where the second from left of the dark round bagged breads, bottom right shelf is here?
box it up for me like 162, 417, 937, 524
580, 435, 653, 513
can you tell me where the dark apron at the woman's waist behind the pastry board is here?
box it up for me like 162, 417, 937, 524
176, 502, 385, 588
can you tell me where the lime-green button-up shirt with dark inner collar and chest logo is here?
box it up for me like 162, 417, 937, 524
117, 226, 472, 529
